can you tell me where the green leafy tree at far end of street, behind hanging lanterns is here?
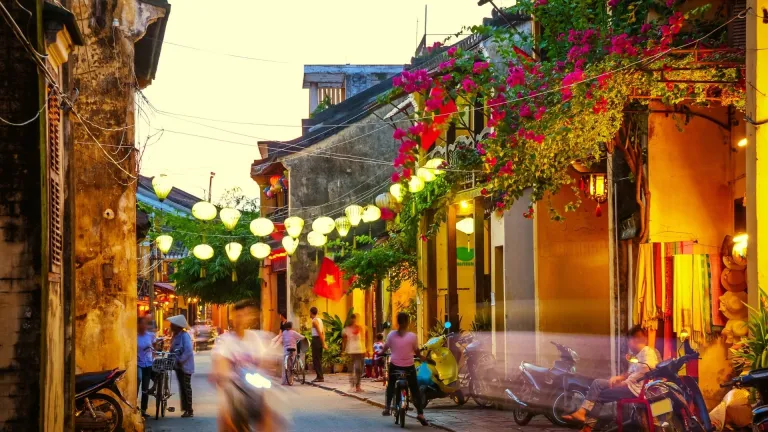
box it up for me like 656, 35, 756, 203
139, 189, 262, 304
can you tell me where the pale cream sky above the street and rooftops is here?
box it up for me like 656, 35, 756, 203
137, 0, 504, 202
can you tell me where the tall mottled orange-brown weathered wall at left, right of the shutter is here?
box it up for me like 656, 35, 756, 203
73, 0, 164, 431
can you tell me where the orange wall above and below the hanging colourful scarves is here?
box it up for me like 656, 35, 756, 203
648, 107, 744, 406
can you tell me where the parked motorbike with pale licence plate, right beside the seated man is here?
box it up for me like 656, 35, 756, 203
593, 343, 713, 432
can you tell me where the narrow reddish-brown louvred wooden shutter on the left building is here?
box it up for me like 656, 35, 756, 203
48, 89, 64, 274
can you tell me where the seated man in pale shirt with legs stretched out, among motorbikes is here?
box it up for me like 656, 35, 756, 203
563, 326, 659, 431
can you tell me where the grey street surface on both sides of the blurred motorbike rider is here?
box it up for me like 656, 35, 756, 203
146, 353, 412, 432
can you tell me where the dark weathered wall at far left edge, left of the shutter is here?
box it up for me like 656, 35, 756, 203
0, 2, 44, 431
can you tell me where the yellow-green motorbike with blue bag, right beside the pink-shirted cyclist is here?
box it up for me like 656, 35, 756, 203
414, 322, 466, 407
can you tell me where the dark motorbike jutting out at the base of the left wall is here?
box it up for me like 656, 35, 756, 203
75, 369, 133, 432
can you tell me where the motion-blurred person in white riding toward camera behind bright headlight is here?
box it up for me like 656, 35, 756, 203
210, 301, 283, 432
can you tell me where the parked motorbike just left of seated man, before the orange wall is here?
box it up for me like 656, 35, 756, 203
505, 342, 594, 426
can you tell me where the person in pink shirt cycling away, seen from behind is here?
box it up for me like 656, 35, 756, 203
382, 312, 429, 426
